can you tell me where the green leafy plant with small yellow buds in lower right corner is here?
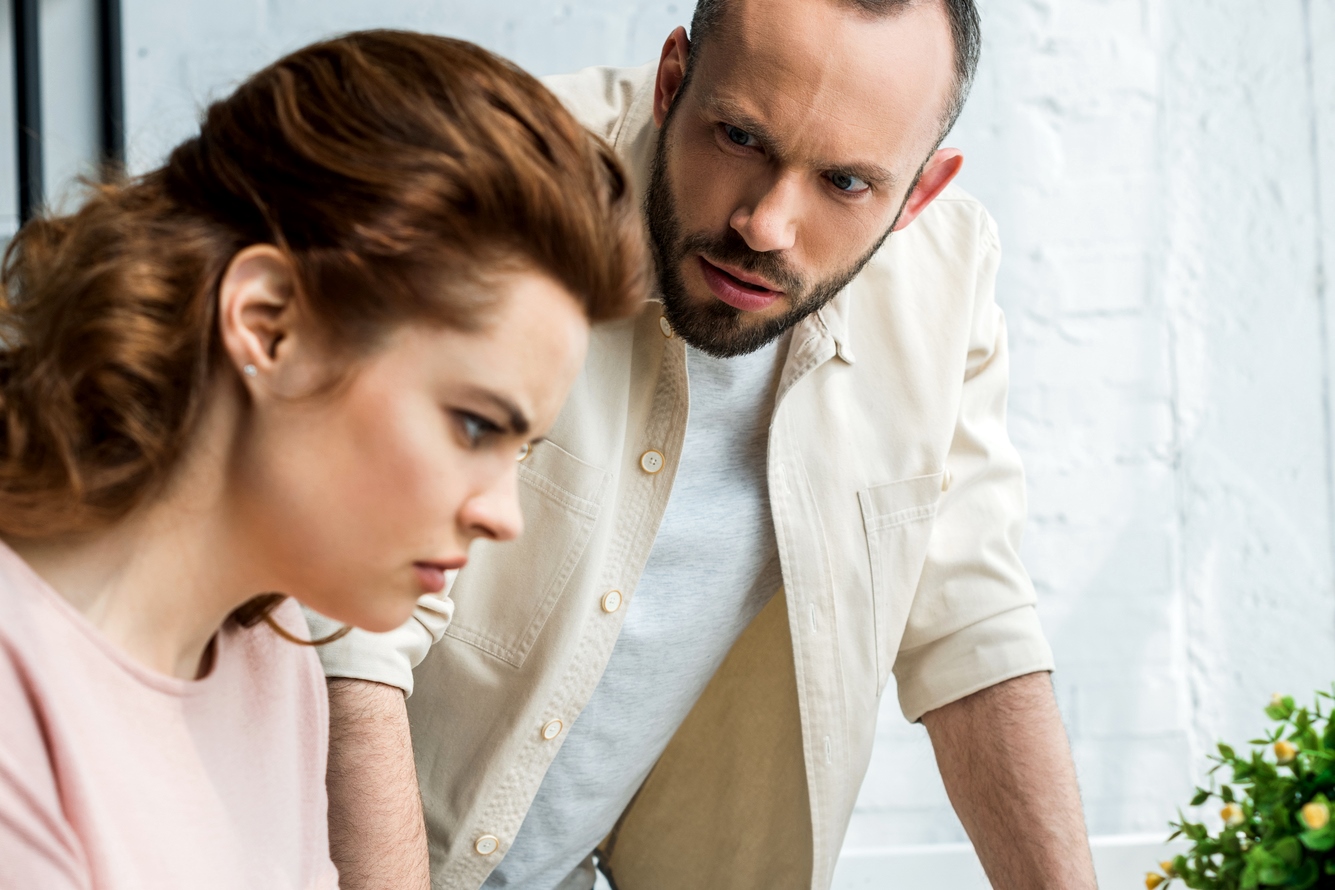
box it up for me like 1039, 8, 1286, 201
1145, 693, 1335, 890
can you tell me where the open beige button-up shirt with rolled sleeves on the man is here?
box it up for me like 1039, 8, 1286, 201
315, 67, 1052, 890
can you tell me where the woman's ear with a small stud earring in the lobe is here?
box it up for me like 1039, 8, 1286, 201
218, 244, 296, 379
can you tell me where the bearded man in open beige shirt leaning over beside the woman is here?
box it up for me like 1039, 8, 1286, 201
315, 0, 1095, 890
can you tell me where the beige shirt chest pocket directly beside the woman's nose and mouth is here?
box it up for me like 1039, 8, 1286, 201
445, 442, 607, 667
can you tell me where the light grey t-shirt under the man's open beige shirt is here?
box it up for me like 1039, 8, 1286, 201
483, 335, 789, 890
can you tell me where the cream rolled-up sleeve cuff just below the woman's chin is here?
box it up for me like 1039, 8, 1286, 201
306, 594, 454, 695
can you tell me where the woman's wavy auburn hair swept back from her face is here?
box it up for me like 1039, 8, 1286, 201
0, 31, 646, 544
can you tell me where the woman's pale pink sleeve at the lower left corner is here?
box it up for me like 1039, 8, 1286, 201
0, 639, 92, 890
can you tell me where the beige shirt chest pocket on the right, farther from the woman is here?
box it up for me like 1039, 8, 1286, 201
857, 472, 941, 695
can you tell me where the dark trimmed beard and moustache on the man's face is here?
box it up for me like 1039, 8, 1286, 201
645, 122, 913, 359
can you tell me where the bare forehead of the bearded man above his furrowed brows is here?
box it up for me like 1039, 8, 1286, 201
693, 0, 955, 168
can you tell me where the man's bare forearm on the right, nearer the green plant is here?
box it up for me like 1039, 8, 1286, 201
922, 673, 1095, 890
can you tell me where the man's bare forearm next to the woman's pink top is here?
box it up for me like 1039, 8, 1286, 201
326, 679, 431, 890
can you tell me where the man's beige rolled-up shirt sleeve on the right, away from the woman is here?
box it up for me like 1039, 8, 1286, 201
894, 215, 1052, 721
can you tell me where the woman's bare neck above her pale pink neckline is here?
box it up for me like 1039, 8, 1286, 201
7, 384, 262, 679
